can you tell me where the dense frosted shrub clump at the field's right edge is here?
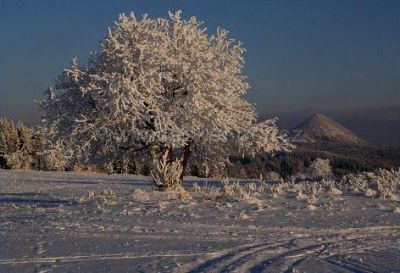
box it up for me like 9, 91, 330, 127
340, 169, 400, 199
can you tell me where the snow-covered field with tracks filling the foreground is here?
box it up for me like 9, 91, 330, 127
0, 170, 400, 272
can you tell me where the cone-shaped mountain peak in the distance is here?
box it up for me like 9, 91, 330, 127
289, 113, 367, 145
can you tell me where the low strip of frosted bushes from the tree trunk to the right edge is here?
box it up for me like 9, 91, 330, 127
192, 169, 400, 203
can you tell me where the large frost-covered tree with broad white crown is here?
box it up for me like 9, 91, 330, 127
41, 11, 291, 189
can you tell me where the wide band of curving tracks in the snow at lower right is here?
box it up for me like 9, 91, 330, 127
188, 227, 400, 273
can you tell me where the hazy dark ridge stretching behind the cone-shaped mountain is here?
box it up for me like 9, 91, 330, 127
260, 106, 400, 146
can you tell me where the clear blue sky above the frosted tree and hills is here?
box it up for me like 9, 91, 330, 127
0, 0, 400, 123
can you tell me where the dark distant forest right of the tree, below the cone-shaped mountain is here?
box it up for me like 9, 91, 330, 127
228, 142, 400, 178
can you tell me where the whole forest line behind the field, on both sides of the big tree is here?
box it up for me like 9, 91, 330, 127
0, 119, 400, 178
